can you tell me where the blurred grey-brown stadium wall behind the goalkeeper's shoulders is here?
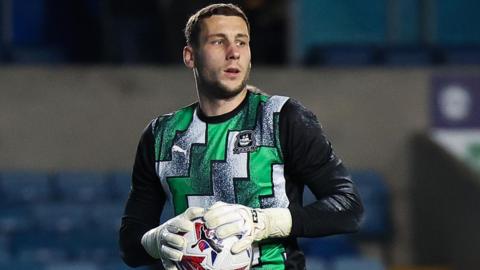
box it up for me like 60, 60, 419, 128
0, 66, 479, 263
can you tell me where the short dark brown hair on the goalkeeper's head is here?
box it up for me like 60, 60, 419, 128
185, 4, 250, 47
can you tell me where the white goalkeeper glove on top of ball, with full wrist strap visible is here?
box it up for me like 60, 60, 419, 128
203, 202, 292, 254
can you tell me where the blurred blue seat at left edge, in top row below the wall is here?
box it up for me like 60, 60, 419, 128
0, 171, 52, 204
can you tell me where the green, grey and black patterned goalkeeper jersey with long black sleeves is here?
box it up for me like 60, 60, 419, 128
120, 89, 362, 269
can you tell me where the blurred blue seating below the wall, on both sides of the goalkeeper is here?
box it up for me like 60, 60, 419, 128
0, 171, 391, 270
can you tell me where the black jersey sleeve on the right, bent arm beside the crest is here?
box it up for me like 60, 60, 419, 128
280, 99, 363, 237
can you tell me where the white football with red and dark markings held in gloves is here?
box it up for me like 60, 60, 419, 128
177, 218, 252, 270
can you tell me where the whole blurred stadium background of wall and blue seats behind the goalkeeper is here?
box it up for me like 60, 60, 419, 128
0, 0, 480, 270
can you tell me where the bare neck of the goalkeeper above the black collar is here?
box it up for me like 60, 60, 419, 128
198, 88, 248, 116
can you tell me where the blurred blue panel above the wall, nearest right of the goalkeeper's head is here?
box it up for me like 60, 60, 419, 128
293, 0, 387, 64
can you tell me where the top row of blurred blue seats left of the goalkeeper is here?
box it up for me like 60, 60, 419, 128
0, 171, 131, 206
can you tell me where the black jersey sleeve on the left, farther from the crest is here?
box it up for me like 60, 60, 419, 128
120, 121, 165, 267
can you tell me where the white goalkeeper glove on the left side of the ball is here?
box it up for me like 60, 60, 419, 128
141, 207, 205, 270
